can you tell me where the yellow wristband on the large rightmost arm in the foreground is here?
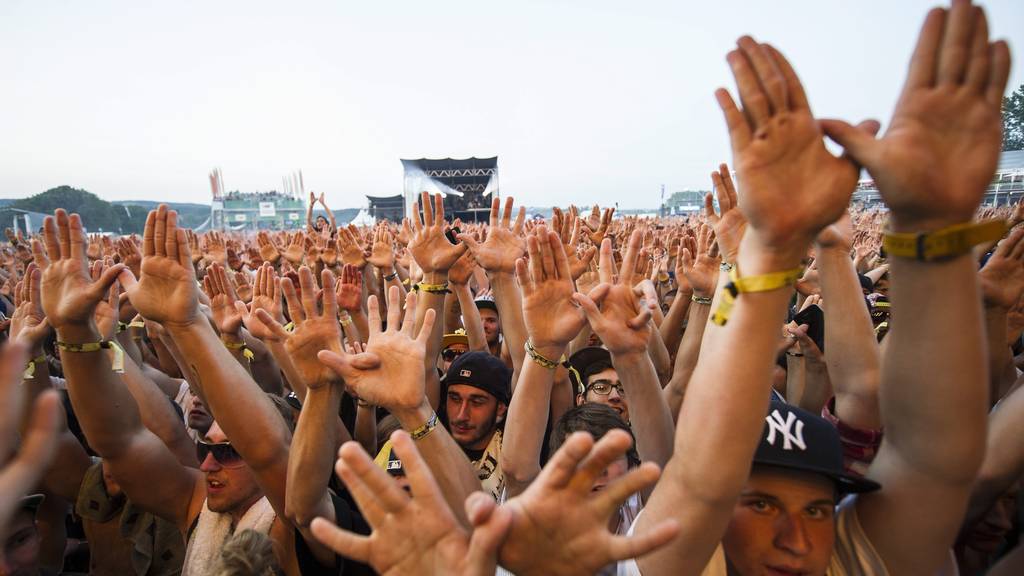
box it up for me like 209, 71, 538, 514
882, 218, 1008, 262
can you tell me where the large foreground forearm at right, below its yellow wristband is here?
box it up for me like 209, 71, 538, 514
880, 254, 988, 483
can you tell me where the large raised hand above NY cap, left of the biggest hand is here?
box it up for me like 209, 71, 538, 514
716, 36, 878, 260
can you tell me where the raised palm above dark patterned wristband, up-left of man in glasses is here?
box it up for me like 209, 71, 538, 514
516, 225, 587, 358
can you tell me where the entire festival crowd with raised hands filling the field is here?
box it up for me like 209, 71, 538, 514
0, 0, 1024, 576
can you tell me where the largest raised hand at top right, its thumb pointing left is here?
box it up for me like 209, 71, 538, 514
821, 1, 1010, 232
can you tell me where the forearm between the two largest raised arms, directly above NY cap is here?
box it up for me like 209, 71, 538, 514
817, 247, 882, 429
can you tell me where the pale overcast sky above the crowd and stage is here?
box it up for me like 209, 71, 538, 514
0, 0, 1024, 208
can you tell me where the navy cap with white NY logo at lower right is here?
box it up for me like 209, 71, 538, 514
754, 398, 882, 494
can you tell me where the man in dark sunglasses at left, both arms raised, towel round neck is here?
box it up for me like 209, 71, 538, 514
36, 210, 366, 576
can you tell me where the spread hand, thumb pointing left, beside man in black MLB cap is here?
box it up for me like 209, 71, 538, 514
317, 286, 434, 412
